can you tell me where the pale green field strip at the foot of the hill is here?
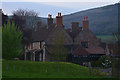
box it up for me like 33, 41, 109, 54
97, 35, 116, 43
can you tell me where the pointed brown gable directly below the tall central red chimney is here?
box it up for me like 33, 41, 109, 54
45, 26, 72, 45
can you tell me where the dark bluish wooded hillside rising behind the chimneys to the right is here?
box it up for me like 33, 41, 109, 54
42, 3, 120, 35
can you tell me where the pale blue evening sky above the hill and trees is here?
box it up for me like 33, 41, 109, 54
0, 0, 119, 17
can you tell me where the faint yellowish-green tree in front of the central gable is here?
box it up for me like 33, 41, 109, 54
51, 32, 67, 61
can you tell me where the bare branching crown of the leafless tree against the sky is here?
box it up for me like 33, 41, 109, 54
13, 9, 38, 28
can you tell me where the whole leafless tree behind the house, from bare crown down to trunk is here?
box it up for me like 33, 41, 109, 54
12, 9, 38, 45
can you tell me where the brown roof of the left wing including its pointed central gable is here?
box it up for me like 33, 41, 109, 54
32, 24, 72, 44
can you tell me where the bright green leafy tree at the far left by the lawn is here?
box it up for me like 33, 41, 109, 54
2, 21, 23, 59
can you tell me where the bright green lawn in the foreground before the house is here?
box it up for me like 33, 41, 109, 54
2, 60, 108, 78
